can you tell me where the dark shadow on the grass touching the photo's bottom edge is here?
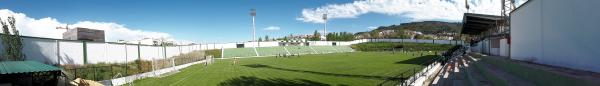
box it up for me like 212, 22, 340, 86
218, 76, 331, 86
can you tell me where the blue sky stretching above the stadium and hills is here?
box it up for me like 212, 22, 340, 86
0, 0, 510, 43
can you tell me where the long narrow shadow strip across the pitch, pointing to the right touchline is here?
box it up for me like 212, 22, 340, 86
243, 64, 402, 80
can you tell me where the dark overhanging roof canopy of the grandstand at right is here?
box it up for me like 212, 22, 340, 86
461, 13, 502, 35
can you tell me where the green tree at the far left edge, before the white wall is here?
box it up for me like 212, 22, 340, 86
0, 17, 24, 61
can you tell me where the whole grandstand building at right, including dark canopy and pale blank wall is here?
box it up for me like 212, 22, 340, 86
462, 0, 600, 72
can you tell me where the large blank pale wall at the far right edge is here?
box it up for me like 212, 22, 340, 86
510, 0, 600, 72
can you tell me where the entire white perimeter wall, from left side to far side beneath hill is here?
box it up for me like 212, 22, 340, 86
0, 37, 462, 65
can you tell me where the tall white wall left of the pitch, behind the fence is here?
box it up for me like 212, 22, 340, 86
0, 35, 201, 65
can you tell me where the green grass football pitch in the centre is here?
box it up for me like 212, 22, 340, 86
134, 52, 433, 86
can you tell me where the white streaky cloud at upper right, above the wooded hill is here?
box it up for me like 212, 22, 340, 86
296, 0, 524, 23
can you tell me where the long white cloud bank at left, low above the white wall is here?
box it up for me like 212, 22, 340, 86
0, 9, 172, 42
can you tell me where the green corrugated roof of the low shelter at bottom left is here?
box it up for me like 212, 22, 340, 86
0, 61, 60, 74
